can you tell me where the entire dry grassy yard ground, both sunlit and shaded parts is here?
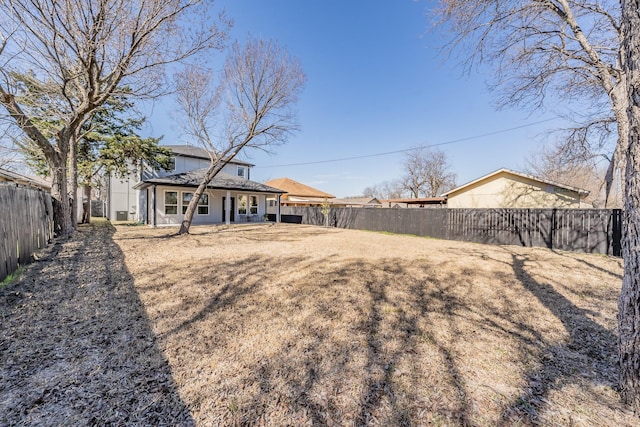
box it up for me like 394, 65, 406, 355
0, 219, 638, 426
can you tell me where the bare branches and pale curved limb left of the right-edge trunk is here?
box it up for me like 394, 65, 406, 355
438, 0, 629, 207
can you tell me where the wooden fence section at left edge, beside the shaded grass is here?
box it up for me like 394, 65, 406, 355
0, 183, 53, 281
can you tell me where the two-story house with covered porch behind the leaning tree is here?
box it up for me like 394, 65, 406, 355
107, 145, 283, 226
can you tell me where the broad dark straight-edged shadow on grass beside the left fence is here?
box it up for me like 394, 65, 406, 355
0, 224, 194, 426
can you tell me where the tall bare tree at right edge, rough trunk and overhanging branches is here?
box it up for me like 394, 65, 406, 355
440, 0, 640, 413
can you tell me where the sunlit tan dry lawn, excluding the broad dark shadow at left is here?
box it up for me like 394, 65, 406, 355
113, 224, 638, 426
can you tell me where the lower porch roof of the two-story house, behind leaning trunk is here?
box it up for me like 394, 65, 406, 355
133, 168, 284, 194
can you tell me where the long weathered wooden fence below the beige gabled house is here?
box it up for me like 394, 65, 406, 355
281, 207, 622, 256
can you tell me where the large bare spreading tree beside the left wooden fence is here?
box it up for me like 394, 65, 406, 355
0, 0, 226, 234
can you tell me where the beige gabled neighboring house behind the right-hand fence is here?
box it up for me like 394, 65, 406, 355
442, 169, 589, 208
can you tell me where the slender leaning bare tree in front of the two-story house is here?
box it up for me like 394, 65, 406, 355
177, 37, 306, 234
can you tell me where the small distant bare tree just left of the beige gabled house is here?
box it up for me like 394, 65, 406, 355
401, 148, 456, 198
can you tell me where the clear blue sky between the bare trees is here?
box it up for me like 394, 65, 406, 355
144, 0, 562, 197
